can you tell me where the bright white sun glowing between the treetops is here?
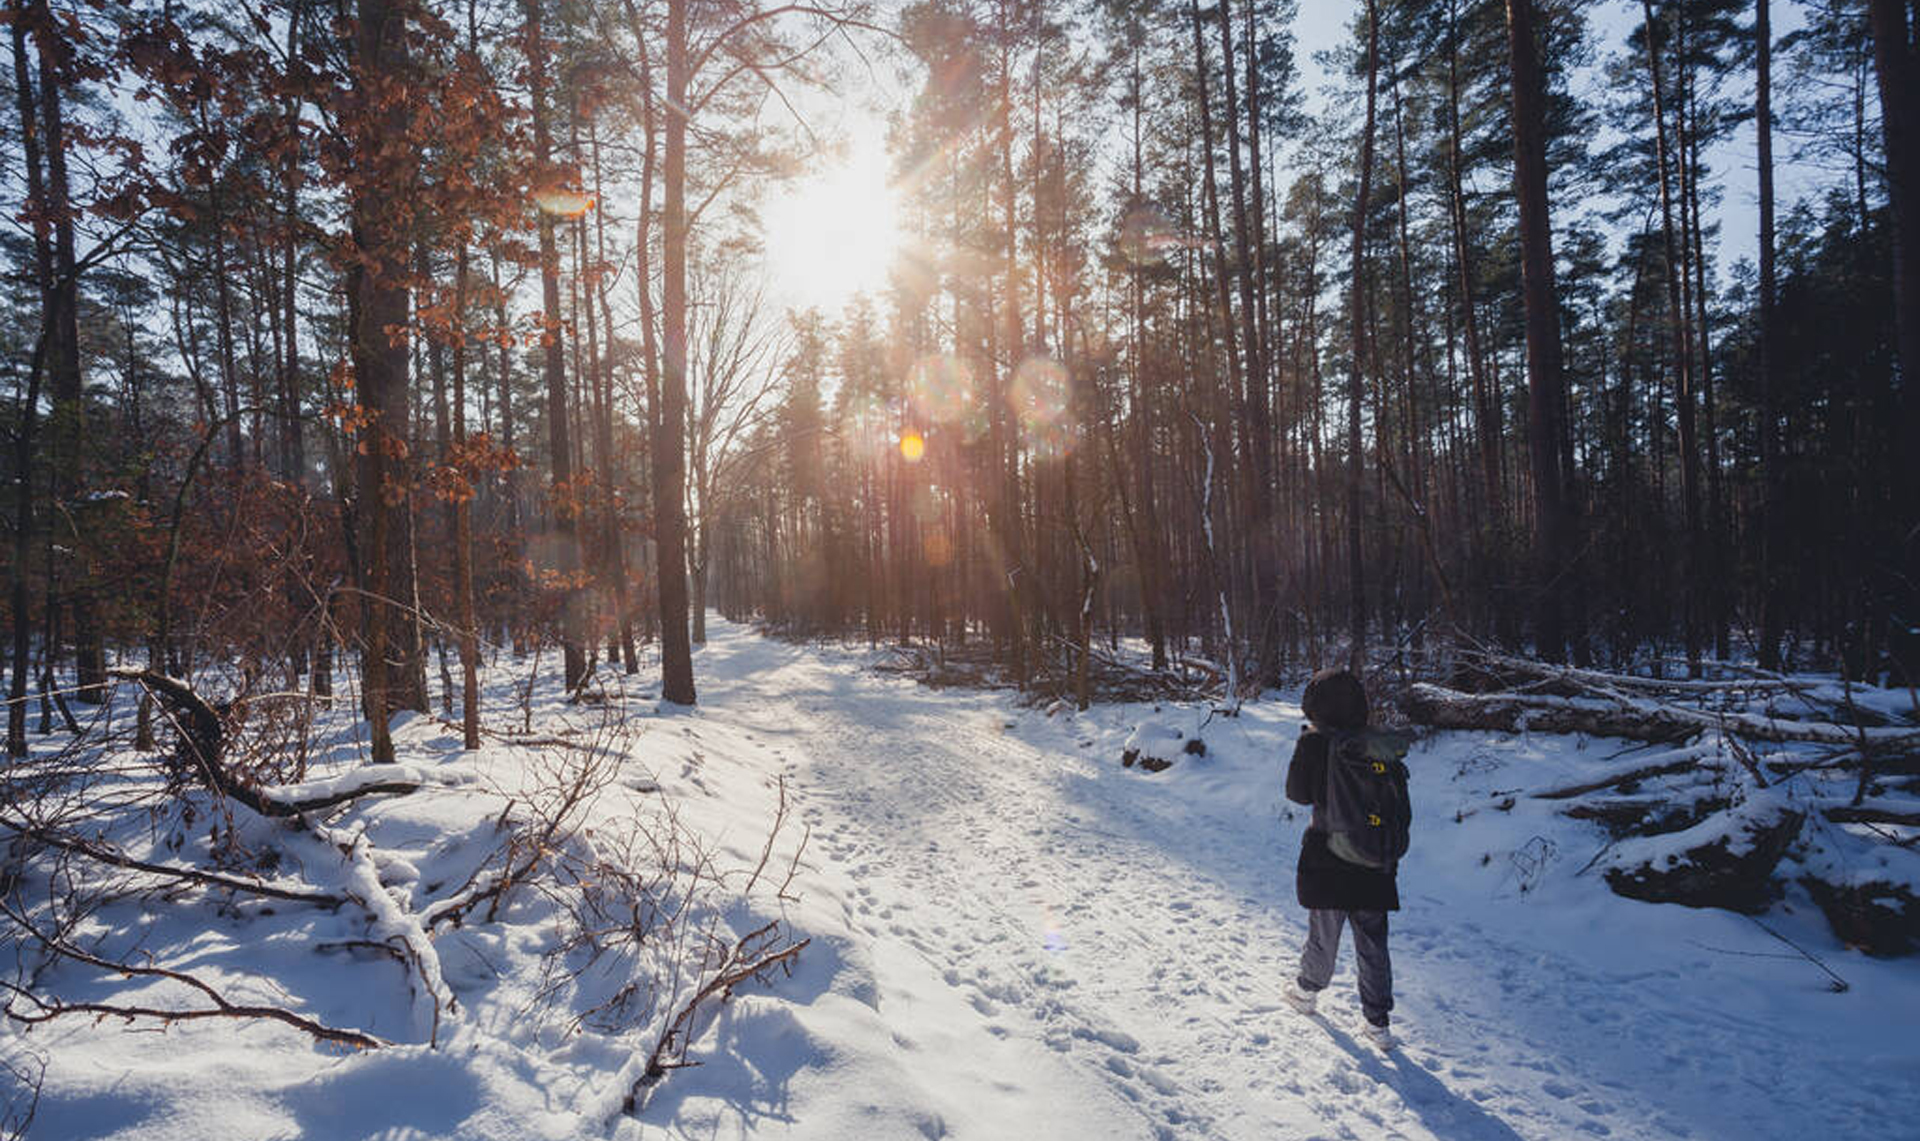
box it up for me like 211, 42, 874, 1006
762, 140, 900, 313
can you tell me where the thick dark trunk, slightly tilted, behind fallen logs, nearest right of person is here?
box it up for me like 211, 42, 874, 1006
1507, 0, 1571, 661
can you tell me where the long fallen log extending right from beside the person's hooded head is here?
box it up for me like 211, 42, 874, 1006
1407, 682, 1920, 749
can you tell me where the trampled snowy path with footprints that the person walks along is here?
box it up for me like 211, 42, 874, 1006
660, 624, 1920, 1141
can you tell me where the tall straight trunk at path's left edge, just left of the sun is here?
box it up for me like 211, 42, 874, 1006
653, 0, 697, 705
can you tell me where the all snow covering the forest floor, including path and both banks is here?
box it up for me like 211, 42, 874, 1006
23, 619, 1920, 1141
